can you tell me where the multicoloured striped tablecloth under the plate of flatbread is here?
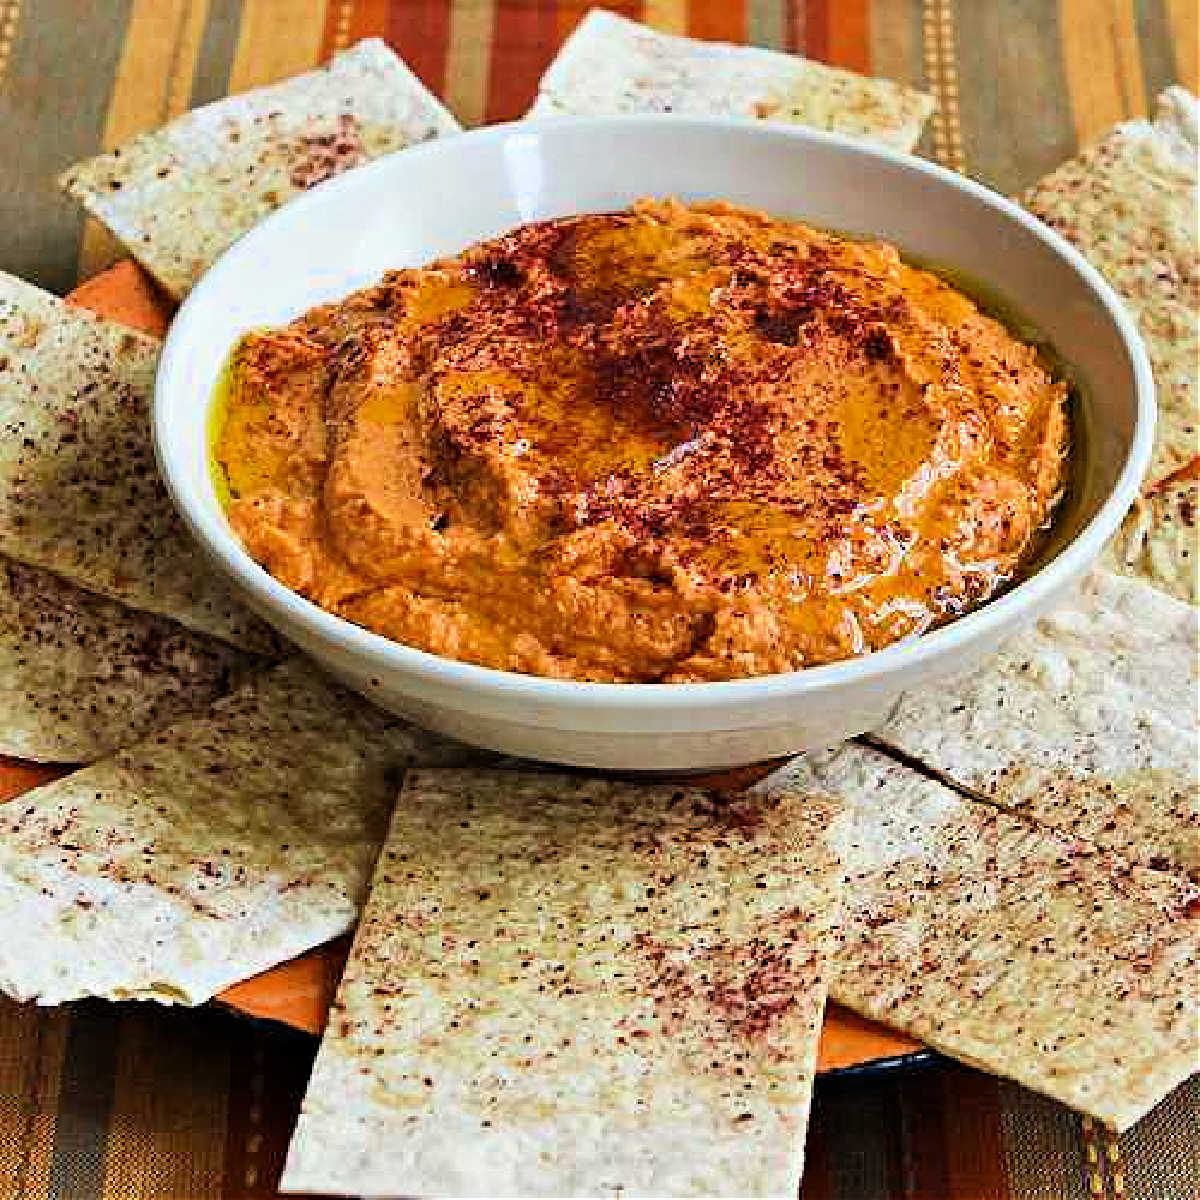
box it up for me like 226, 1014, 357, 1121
0, 0, 1200, 1200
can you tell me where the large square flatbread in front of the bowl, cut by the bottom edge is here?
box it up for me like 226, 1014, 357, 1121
282, 770, 841, 1198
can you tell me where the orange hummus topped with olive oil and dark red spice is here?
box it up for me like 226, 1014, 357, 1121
216, 202, 1068, 682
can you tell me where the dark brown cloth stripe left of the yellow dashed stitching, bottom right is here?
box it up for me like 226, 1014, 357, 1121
996, 1080, 1088, 1200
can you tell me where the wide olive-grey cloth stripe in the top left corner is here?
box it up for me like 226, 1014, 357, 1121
0, 0, 130, 292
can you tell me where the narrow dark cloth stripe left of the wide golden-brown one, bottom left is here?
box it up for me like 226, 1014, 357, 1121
49, 1002, 120, 1200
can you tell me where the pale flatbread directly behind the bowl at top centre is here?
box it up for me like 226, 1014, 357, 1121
527, 8, 934, 150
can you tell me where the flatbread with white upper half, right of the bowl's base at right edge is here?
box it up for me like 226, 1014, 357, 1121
872, 570, 1200, 878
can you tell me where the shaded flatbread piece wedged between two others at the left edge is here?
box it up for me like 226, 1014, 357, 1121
0, 558, 253, 762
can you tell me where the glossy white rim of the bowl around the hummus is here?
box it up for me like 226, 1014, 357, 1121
152, 113, 1157, 713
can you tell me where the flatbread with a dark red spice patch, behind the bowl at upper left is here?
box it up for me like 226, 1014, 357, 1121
59, 38, 458, 300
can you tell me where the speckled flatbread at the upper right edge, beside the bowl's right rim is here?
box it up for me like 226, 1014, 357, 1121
1025, 88, 1200, 485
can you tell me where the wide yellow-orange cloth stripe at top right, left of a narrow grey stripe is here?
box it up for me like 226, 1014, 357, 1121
1058, 0, 1146, 145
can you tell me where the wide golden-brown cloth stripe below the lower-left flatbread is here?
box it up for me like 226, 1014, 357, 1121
97, 1004, 229, 1200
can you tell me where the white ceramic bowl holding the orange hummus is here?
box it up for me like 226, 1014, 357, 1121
154, 116, 1154, 770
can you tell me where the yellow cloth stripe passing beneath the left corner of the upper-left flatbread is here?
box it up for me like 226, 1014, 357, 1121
79, 0, 209, 280
